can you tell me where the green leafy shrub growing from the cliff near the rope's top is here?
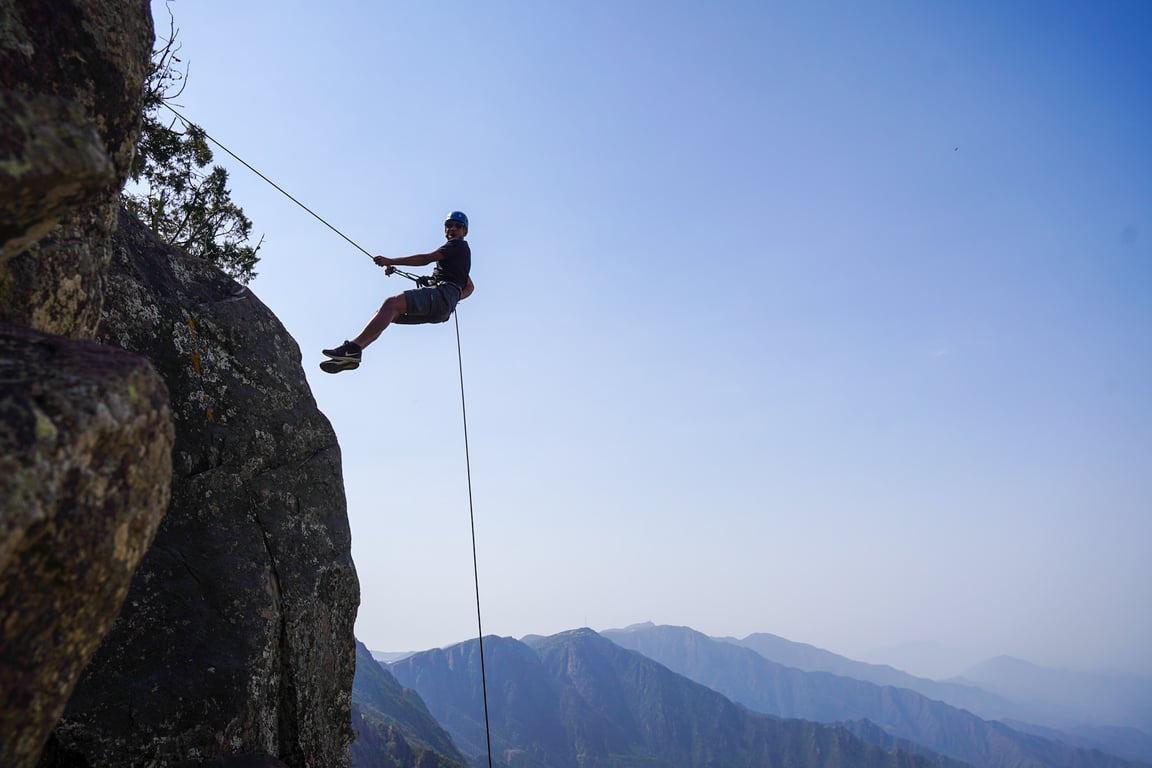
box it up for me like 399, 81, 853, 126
123, 20, 263, 283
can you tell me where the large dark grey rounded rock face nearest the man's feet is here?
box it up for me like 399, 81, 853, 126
44, 213, 359, 768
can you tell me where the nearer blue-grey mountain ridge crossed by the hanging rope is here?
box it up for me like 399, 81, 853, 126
391, 630, 957, 768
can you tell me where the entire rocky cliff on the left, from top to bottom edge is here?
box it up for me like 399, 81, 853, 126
0, 0, 358, 768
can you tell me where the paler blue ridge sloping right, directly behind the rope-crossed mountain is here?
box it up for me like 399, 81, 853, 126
602, 625, 1132, 768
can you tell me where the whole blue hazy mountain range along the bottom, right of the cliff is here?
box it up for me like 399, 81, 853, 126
354, 624, 1147, 768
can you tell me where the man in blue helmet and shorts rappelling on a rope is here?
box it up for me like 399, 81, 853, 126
320, 211, 475, 373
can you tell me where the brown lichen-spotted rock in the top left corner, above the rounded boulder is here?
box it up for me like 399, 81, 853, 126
0, 0, 154, 339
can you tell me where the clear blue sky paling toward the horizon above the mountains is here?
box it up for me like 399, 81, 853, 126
153, 0, 1152, 674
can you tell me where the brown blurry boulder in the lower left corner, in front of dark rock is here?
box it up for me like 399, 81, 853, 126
0, 326, 173, 768
